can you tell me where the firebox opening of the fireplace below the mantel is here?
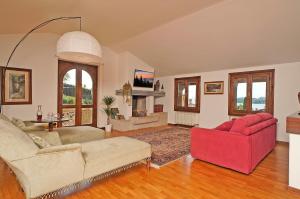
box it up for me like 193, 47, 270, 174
132, 95, 147, 117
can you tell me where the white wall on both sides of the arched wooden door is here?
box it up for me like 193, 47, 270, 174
0, 33, 118, 126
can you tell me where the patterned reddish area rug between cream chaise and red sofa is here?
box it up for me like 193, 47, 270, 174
129, 127, 190, 166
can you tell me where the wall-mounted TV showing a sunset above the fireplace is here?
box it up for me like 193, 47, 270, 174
133, 69, 154, 88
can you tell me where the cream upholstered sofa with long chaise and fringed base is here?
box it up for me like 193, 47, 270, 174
0, 115, 151, 198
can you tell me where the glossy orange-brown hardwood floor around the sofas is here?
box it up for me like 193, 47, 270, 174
0, 127, 300, 199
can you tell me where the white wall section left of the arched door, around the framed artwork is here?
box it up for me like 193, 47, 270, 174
0, 34, 59, 119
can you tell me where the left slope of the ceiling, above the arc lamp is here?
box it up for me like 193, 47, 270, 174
0, 0, 222, 45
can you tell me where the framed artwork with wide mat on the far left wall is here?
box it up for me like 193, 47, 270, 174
2, 68, 32, 105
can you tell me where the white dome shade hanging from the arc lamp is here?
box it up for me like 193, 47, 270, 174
56, 31, 102, 64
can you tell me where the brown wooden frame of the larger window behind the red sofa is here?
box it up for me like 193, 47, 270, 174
228, 69, 275, 116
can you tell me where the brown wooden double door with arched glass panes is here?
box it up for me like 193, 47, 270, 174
58, 61, 97, 126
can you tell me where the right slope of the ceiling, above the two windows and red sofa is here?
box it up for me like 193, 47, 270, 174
112, 0, 300, 76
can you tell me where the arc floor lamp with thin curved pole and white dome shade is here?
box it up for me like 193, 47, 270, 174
0, 17, 102, 112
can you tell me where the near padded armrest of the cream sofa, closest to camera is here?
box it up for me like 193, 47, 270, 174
10, 144, 85, 198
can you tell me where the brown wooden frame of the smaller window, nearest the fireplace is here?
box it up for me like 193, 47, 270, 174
174, 76, 201, 113
